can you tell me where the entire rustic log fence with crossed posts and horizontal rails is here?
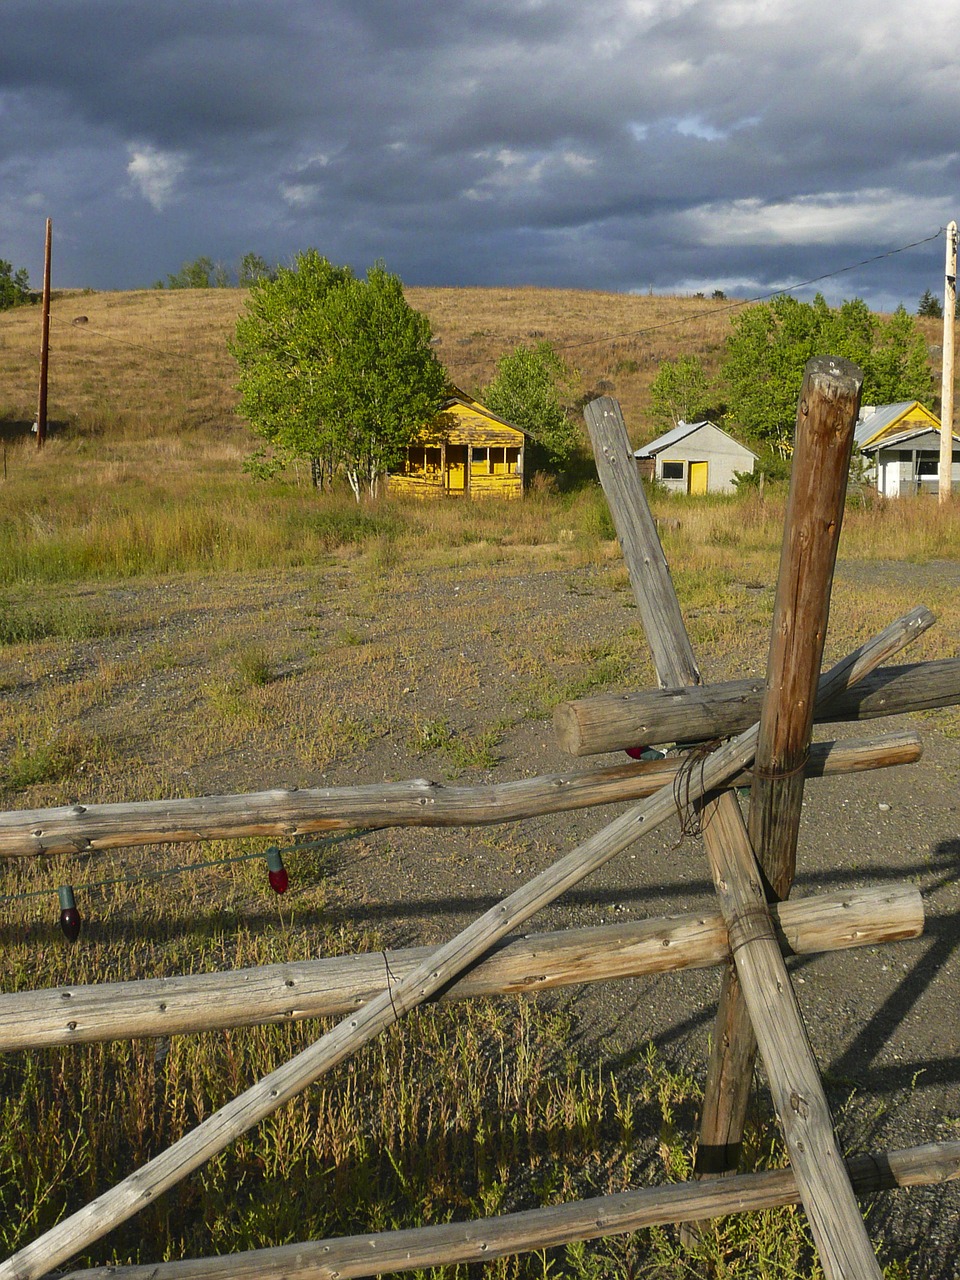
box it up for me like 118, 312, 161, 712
0, 361, 960, 1280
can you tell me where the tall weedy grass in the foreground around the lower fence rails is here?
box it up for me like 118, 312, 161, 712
0, 864, 839, 1277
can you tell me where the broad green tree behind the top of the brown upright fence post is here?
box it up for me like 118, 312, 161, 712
721, 294, 933, 456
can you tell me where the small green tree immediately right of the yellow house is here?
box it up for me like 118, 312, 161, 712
483, 342, 580, 470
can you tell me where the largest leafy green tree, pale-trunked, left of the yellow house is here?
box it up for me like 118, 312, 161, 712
230, 250, 447, 500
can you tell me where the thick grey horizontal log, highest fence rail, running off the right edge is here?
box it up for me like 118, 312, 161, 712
553, 658, 960, 755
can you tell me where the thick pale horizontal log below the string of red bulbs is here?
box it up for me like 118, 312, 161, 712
0, 884, 923, 1052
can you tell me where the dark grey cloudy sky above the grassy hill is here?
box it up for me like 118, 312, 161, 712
0, 0, 960, 310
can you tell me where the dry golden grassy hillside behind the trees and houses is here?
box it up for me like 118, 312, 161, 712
0, 288, 752, 450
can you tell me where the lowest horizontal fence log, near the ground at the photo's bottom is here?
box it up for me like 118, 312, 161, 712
54, 1142, 960, 1280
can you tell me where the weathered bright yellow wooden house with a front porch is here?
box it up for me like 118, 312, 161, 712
389, 387, 527, 498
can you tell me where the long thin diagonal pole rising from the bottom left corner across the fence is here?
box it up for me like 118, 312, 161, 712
0, 609, 932, 1280
